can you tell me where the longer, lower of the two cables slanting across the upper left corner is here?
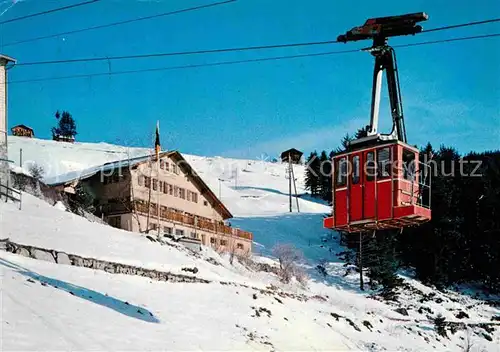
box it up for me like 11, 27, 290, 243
3, 0, 237, 47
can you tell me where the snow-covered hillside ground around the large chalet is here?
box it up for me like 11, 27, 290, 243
0, 137, 500, 351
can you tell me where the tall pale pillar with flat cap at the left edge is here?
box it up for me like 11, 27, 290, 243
0, 54, 16, 191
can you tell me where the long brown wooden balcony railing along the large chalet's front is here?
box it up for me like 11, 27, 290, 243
133, 201, 253, 241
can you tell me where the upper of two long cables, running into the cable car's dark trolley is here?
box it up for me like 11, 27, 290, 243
11, 17, 500, 66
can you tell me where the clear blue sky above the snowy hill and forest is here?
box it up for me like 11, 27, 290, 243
0, 0, 500, 158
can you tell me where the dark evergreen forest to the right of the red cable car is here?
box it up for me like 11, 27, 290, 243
399, 145, 500, 292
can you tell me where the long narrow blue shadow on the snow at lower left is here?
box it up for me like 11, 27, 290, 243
0, 259, 160, 323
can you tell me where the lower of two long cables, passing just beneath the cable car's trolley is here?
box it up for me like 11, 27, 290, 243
8, 33, 500, 84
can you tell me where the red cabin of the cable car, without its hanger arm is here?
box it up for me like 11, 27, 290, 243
324, 140, 431, 232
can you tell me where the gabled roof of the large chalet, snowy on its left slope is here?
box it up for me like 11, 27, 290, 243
46, 150, 233, 219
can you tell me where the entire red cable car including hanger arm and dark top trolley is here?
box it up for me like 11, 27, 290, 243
324, 13, 431, 233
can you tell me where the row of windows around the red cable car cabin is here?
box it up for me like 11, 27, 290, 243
335, 148, 415, 187
